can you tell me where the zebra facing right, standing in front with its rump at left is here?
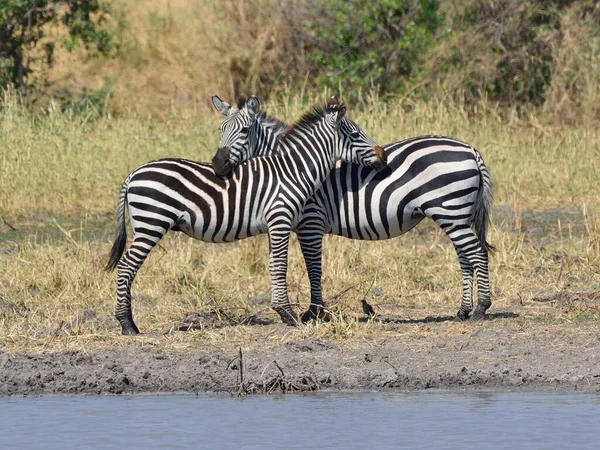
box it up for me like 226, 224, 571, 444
106, 97, 386, 335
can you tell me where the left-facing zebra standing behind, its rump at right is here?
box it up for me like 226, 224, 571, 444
213, 96, 492, 322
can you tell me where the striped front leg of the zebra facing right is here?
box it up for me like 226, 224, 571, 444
269, 226, 298, 326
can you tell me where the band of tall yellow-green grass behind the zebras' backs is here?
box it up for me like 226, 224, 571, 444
0, 93, 600, 217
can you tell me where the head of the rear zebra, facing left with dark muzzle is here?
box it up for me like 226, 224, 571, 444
212, 95, 260, 177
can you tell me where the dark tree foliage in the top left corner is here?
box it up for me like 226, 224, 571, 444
0, 0, 112, 93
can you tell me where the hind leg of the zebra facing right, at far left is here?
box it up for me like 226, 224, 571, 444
115, 237, 157, 335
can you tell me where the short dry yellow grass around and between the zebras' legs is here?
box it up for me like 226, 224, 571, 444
0, 219, 600, 351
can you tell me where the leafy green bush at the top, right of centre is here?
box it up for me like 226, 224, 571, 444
309, 0, 444, 96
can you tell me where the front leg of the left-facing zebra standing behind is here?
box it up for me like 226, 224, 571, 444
298, 226, 331, 323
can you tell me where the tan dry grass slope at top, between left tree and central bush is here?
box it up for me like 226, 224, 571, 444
39, 0, 304, 114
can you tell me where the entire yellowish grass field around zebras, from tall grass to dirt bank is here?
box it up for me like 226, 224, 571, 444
0, 93, 600, 351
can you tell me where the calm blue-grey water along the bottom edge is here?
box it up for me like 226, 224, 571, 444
0, 392, 600, 449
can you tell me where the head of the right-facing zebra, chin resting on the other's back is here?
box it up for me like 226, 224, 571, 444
325, 96, 387, 170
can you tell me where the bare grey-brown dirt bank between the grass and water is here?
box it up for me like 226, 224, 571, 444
0, 309, 600, 396
